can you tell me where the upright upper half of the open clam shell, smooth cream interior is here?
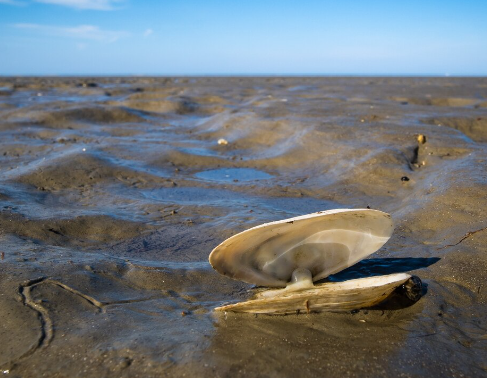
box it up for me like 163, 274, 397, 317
209, 209, 393, 287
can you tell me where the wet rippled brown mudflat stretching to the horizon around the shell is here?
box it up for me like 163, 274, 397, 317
0, 78, 487, 377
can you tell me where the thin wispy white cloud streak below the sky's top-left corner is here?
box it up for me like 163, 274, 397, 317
14, 24, 129, 43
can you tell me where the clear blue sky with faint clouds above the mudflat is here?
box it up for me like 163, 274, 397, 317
0, 0, 487, 76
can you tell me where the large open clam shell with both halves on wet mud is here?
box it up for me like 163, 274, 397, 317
209, 209, 424, 314
